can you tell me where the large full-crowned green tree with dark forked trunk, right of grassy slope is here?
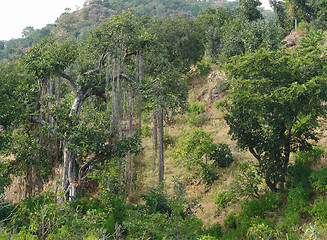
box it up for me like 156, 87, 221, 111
225, 36, 327, 191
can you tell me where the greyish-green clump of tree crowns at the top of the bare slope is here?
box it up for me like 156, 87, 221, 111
198, 7, 283, 62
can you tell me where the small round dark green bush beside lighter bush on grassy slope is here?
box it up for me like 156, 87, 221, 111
210, 143, 234, 168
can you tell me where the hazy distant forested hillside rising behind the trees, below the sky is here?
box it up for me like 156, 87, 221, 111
0, 0, 274, 60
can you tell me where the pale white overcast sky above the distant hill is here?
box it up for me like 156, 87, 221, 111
0, 0, 269, 40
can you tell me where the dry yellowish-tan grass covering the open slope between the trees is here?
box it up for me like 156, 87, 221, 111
135, 69, 254, 227
